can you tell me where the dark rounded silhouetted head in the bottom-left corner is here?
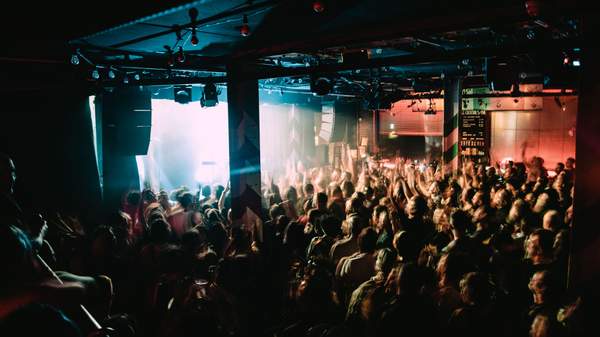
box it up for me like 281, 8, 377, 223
0, 303, 82, 337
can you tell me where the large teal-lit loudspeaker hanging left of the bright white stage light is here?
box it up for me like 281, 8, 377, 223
102, 87, 152, 155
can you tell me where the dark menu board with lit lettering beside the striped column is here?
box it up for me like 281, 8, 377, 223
458, 110, 490, 160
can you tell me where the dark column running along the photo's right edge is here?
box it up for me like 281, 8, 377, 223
569, 15, 600, 290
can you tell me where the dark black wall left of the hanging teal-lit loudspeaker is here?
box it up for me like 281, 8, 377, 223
0, 83, 100, 220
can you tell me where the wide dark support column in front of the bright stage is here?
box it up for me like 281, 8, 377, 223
227, 67, 262, 225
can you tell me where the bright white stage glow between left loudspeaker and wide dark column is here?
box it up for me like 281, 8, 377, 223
138, 99, 229, 190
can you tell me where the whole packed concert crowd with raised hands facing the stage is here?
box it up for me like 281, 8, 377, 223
0, 150, 591, 337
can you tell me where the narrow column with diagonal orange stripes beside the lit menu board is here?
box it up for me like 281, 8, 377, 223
442, 77, 462, 174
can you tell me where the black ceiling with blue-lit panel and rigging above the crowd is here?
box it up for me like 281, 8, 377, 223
0, 0, 581, 94
